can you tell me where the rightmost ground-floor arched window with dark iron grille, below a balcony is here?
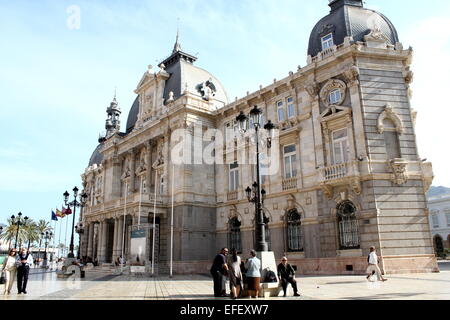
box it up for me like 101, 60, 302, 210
337, 201, 359, 250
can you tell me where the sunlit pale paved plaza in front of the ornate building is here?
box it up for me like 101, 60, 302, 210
0, 262, 450, 301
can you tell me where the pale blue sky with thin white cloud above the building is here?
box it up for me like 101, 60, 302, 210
0, 0, 450, 238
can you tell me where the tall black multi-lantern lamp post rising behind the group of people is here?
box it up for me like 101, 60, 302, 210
236, 106, 275, 252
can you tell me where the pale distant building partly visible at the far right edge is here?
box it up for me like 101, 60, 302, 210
428, 195, 450, 255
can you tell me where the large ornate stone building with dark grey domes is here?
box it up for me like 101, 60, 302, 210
81, 0, 437, 274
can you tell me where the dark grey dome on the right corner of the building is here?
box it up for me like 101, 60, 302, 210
308, 0, 399, 57
